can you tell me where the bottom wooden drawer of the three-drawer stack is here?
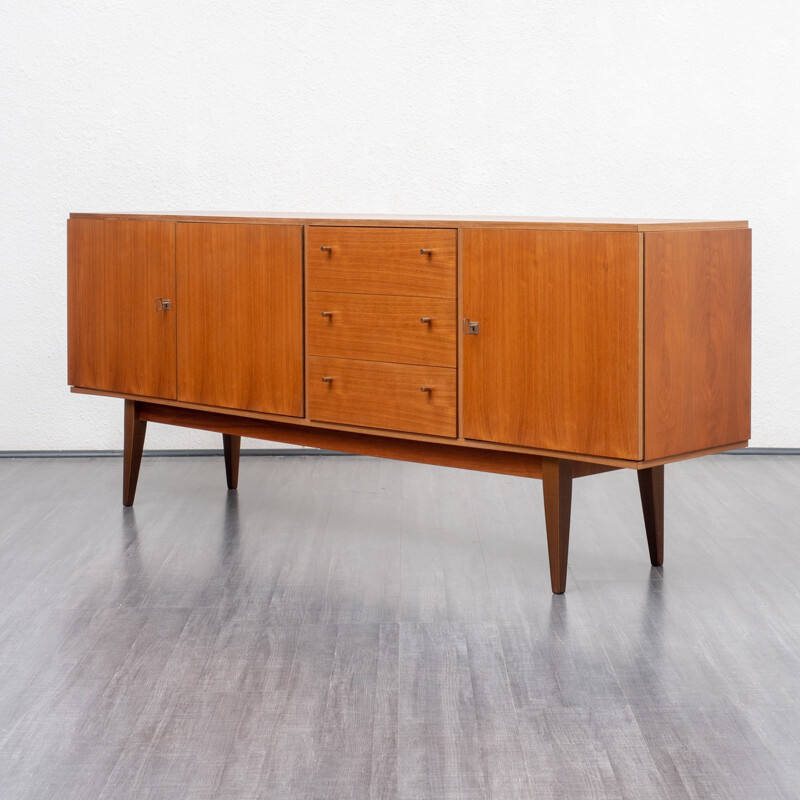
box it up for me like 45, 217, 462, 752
308, 356, 456, 437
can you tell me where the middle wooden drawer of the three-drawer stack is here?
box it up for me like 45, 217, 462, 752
307, 292, 456, 367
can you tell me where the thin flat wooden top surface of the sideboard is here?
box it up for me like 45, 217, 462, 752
70, 211, 747, 231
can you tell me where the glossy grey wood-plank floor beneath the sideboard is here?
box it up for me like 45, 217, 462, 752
0, 456, 800, 800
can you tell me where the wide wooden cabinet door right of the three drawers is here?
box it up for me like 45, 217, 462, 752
462, 229, 641, 459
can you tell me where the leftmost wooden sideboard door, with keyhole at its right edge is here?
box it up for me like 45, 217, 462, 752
67, 219, 176, 399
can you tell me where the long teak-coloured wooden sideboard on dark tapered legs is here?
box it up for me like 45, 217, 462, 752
68, 214, 751, 593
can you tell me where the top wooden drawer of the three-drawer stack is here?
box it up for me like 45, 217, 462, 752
306, 226, 456, 298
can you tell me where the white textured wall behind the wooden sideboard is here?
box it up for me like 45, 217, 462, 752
0, 0, 800, 450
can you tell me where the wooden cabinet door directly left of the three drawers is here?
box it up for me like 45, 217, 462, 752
177, 223, 303, 416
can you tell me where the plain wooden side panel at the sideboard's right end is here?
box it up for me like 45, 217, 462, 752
644, 229, 751, 459
